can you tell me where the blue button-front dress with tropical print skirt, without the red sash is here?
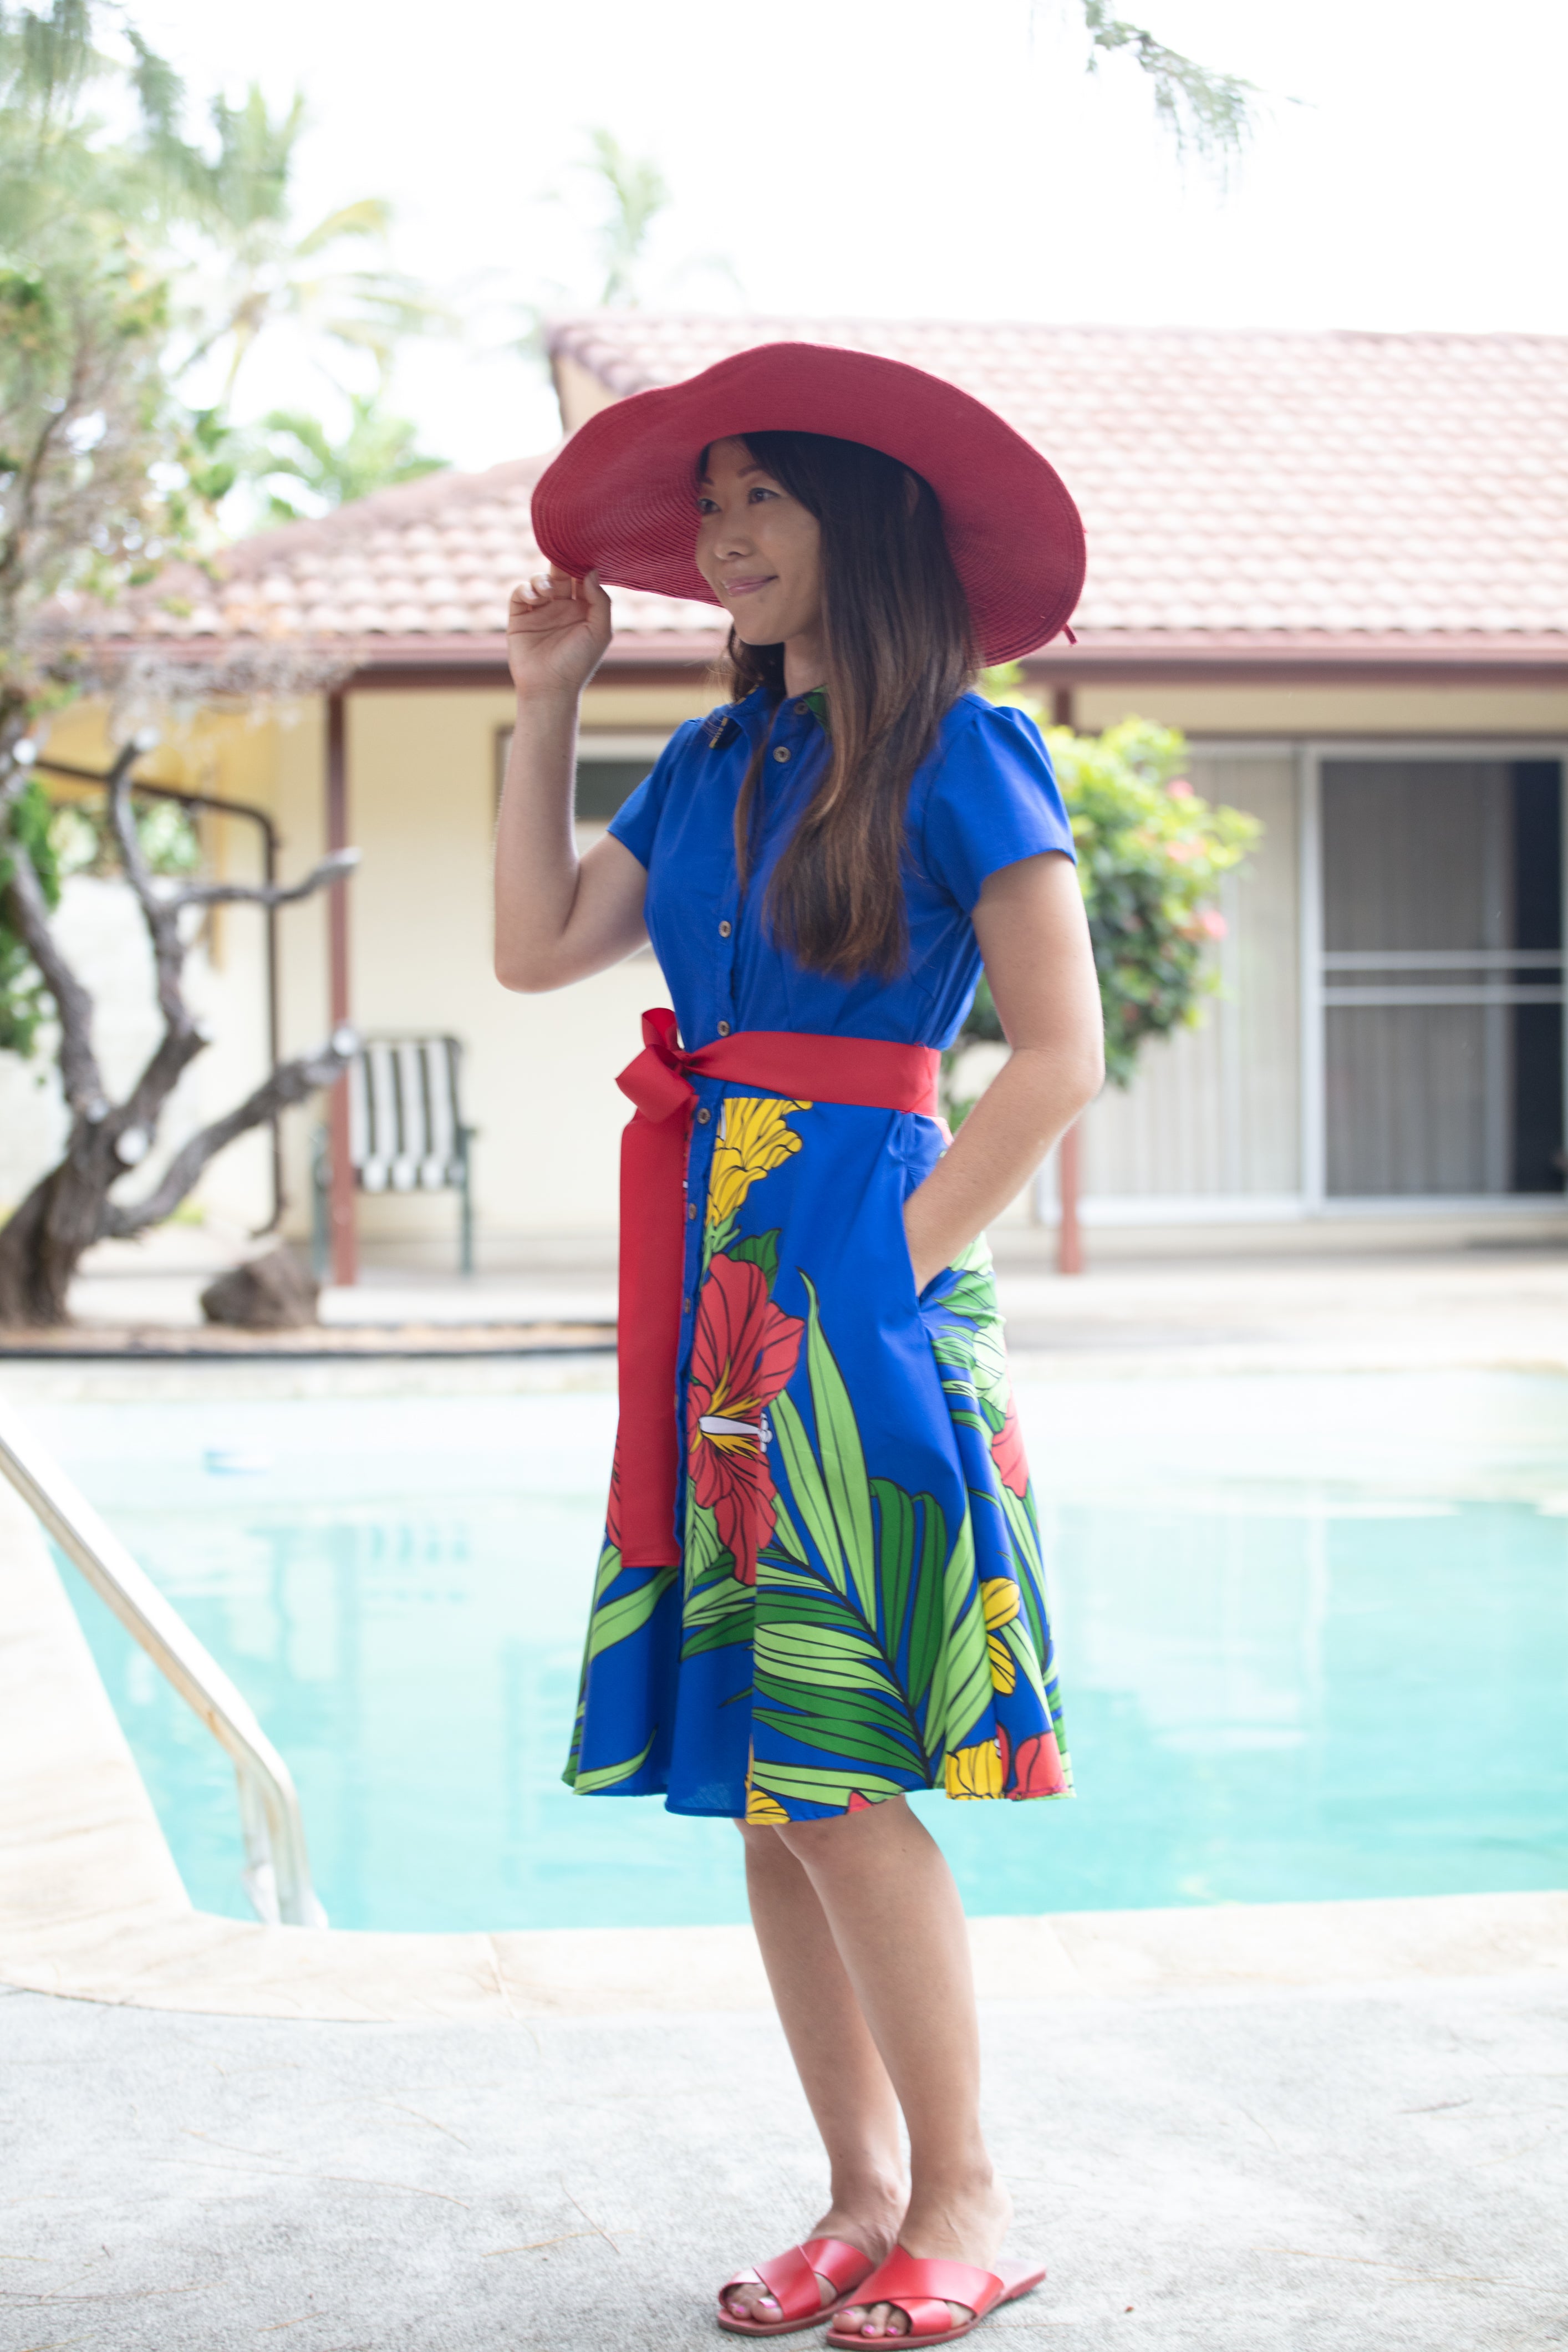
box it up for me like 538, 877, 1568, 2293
567, 691, 1072, 1823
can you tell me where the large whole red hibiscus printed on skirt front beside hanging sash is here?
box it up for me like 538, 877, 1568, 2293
686, 1251, 806, 1585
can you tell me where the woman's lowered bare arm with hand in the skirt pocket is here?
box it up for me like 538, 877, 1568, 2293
903, 852, 1105, 1289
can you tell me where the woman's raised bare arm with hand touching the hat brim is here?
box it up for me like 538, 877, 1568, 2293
496, 572, 649, 990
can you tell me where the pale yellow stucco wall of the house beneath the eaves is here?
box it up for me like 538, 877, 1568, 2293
0, 680, 1568, 1265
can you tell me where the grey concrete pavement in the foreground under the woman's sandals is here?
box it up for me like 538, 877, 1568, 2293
0, 1978, 1568, 2352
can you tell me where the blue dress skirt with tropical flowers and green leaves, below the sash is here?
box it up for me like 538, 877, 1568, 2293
567, 1089, 1072, 1825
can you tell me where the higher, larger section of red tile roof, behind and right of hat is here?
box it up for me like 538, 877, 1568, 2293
550, 310, 1568, 654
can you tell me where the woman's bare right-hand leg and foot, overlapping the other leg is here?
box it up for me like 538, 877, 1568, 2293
773, 1797, 1013, 2335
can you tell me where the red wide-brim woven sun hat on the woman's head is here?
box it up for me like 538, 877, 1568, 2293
533, 343, 1084, 663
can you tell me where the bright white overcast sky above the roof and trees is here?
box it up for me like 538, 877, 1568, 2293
134, 0, 1568, 466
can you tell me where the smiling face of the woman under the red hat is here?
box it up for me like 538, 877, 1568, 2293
696, 440, 823, 644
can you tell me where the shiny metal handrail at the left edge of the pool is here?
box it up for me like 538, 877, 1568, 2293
0, 1402, 327, 1926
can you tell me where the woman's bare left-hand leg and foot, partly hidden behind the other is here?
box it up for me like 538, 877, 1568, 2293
726, 1823, 908, 2319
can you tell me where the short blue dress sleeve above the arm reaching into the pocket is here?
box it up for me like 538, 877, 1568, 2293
922, 699, 1075, 915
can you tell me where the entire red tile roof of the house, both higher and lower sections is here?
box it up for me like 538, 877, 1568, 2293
89, 310, 1568, 668
